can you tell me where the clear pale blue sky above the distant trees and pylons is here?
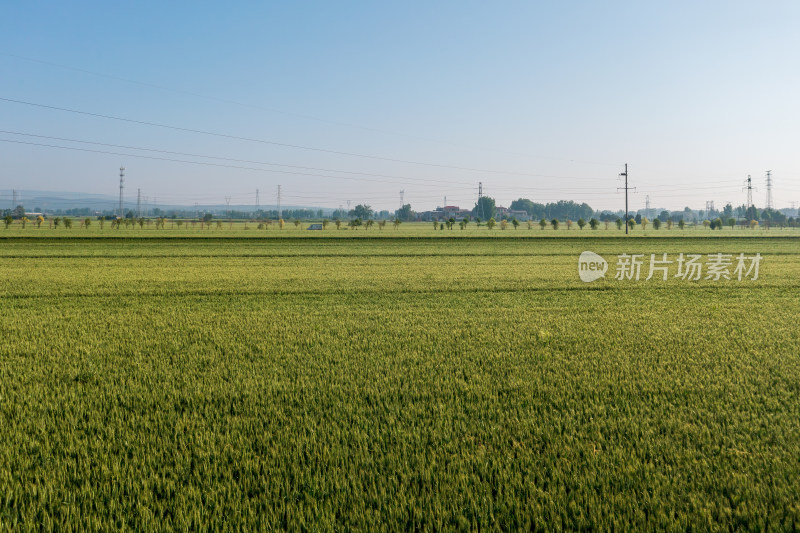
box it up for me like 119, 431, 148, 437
0, 0, 800, 210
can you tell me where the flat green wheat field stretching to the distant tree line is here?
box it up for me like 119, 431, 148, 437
0, 223, 800, 531
